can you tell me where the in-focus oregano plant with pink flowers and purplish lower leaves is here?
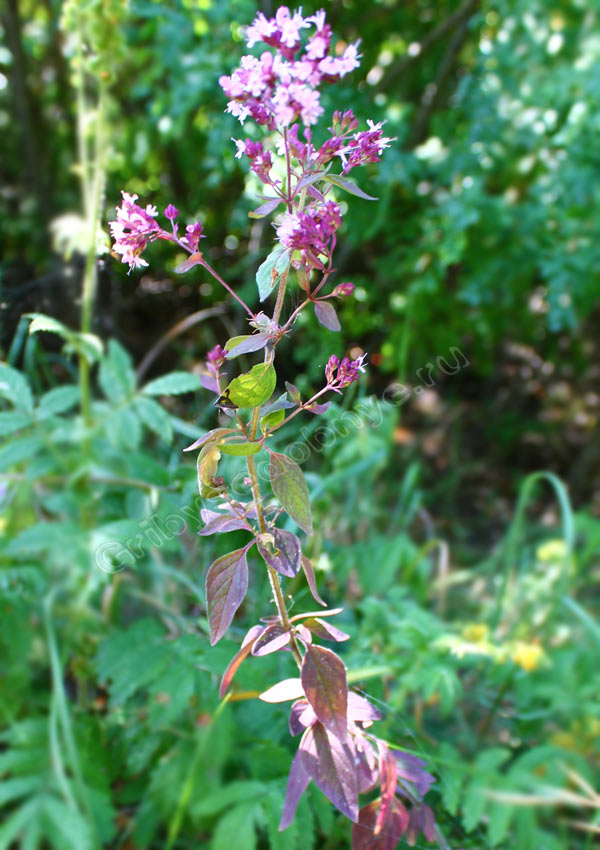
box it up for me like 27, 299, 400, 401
110, 6, 444, 850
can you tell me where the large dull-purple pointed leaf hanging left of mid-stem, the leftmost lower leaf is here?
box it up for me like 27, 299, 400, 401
206, 543, 252, 646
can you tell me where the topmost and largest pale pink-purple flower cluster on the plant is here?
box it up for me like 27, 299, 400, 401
219, 6, 360, 129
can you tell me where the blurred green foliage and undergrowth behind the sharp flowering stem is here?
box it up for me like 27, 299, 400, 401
0, 0, 600, 850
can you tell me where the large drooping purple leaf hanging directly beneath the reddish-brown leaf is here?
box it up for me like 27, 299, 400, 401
298, 723, 358, 821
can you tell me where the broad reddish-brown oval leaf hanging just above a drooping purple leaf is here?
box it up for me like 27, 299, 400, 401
301, 646, 348, 741
